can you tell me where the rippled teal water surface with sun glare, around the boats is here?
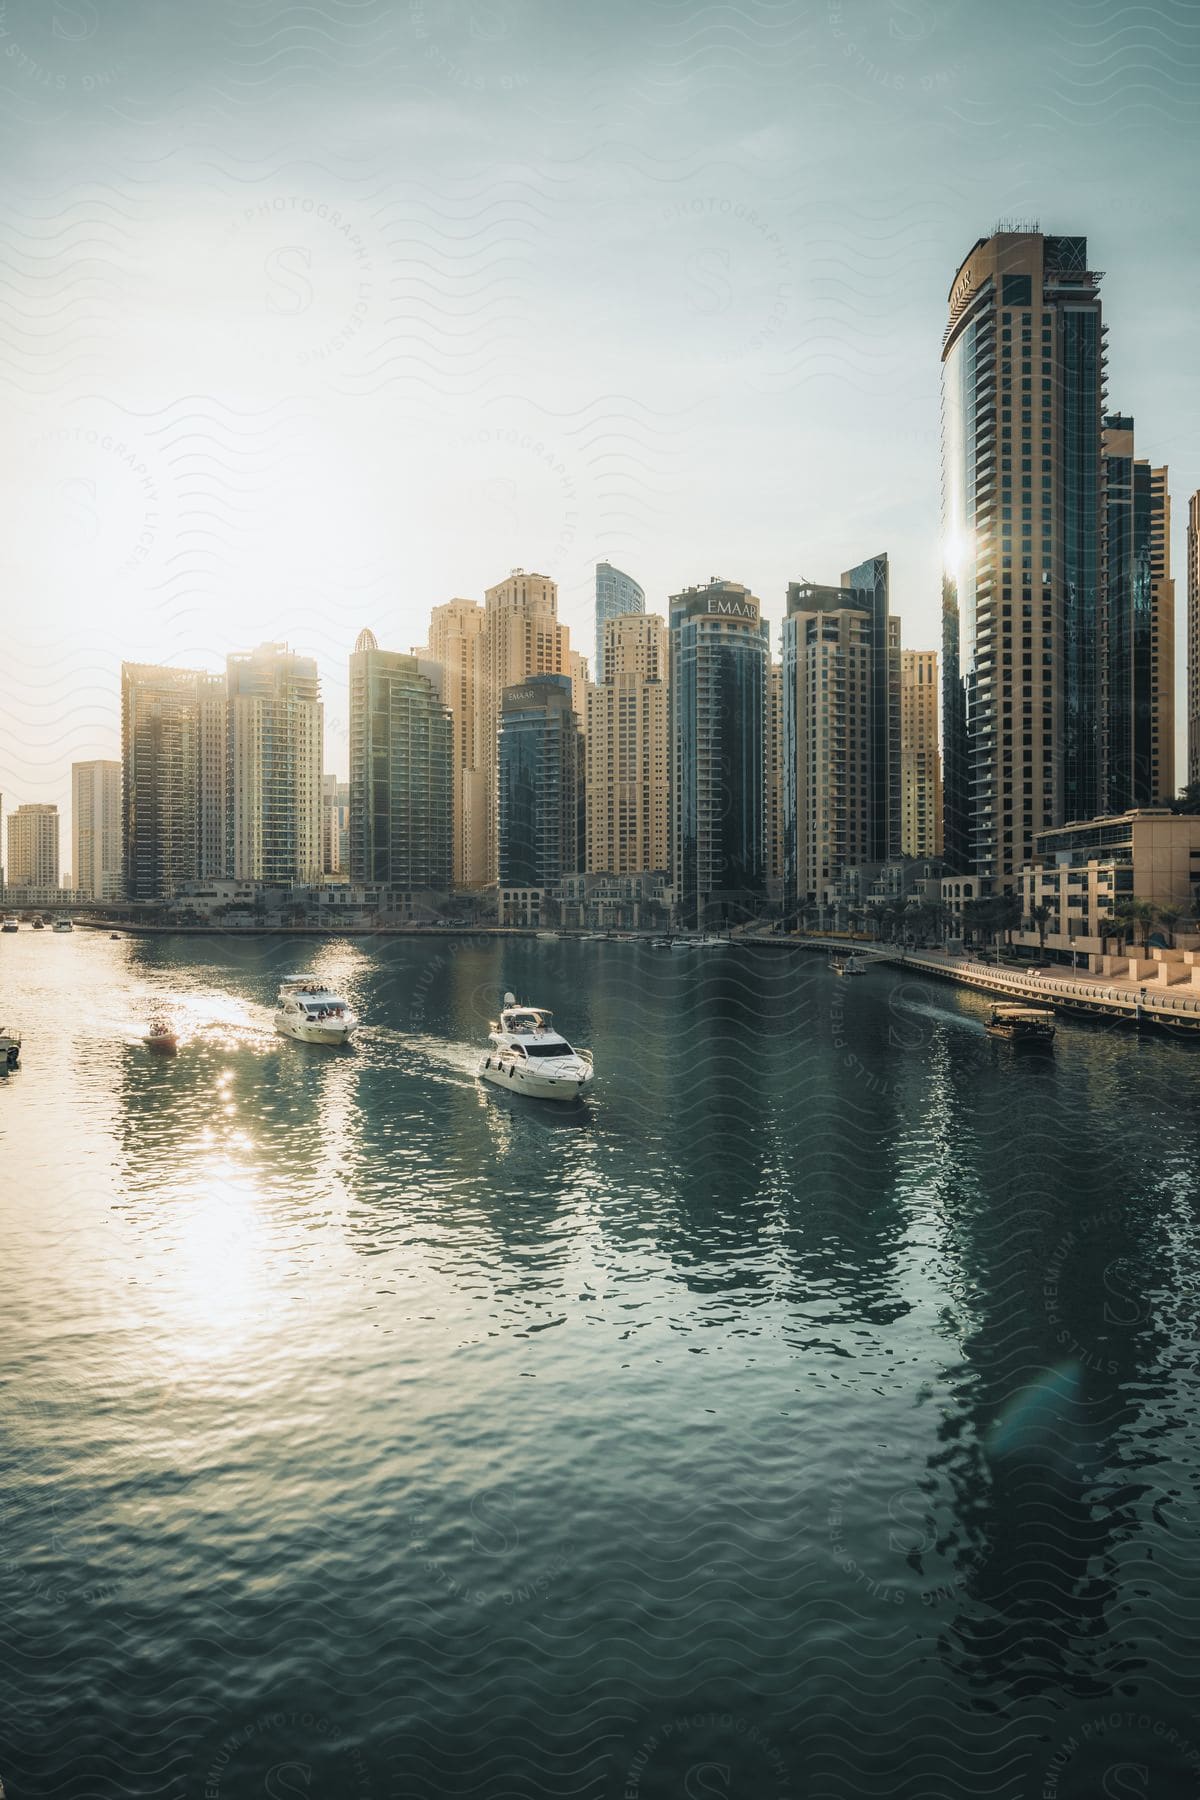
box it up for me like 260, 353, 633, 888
0, 931, 1200, 1800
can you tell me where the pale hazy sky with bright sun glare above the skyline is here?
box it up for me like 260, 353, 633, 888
0, 0, 1200, 868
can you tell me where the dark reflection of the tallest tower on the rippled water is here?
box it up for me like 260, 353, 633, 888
913, 1062, 1164, 1697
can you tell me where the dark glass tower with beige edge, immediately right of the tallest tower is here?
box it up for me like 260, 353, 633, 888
1099, 414, 1175, 812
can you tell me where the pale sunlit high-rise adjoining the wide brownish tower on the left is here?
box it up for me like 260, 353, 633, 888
225, 644, 324, 887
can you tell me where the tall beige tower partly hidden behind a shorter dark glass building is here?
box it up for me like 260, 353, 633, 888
475, 569, 579, 882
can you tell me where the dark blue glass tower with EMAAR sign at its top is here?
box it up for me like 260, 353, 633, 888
669, 576, 770, 927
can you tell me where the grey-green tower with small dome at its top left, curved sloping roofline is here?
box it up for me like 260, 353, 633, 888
351, 632, 455, 893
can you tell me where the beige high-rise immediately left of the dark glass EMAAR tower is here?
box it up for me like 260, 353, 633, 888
586, 612, 669, 875
